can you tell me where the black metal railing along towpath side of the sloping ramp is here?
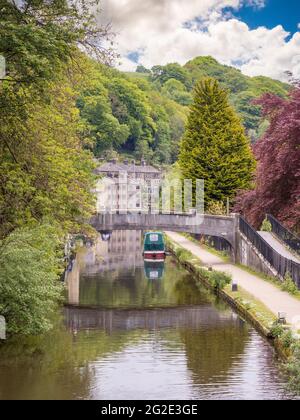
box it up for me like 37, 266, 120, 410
239, 216, 300, 289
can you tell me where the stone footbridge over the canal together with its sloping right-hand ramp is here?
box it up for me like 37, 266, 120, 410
91, 213, 300, 288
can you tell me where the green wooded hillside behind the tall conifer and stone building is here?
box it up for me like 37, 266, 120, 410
68, 57, 288, 164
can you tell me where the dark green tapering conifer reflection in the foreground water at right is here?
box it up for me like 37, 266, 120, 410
180, 323, 249, 384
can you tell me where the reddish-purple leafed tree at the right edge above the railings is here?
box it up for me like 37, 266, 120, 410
236, 83, 300, 232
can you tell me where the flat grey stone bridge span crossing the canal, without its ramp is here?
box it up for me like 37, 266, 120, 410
91, 213, 239, 250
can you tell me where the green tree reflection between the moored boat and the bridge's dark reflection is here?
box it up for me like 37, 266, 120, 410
80, 260, 213, 307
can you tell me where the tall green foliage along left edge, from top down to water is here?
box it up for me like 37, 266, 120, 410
0, 0, 106, 334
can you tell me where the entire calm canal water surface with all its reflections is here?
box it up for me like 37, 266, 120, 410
0, 231, 292, 400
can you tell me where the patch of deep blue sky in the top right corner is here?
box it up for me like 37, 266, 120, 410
234, 0, 300, 33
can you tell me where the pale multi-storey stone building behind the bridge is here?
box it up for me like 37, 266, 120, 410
96, 160, 162, 213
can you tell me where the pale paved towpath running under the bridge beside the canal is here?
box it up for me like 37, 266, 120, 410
166, 232, 300, 328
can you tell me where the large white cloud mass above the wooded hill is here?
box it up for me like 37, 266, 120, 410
101, 0, 300, 79
